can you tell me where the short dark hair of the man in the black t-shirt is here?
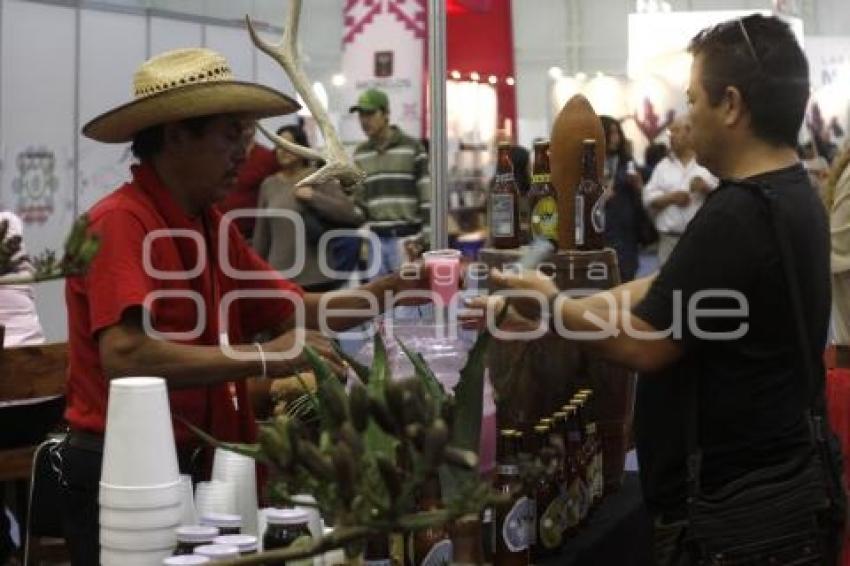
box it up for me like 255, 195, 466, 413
688, 14, 809, 147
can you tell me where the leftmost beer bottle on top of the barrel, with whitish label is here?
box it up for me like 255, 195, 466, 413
489, 142, 520, 250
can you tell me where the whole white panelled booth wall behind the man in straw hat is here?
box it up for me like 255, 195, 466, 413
0, 0, 344, 342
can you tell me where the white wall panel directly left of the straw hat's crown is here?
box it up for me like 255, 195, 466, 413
77, 10, 146, 213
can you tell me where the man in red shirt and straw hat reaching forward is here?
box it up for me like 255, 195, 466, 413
62, 49, 428, 566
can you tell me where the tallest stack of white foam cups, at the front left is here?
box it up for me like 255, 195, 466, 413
99, 377, 183, 566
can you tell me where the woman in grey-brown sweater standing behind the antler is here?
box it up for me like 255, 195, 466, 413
248, 125, 364, 292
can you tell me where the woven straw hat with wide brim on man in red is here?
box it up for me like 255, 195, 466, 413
83, 48, 300, 143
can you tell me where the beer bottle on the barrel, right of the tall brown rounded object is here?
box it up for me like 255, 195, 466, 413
575, 139, 605, 250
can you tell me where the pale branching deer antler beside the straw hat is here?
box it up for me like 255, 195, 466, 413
245, 0, 365, 186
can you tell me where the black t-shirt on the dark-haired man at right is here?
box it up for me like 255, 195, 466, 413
634, 165, 830, 513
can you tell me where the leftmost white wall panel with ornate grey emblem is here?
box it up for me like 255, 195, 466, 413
0, 0, 76, 341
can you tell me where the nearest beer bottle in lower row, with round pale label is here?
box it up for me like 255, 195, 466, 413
493, 429, 531, 566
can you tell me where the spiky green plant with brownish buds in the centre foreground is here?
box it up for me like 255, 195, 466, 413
190, 320, 499, 564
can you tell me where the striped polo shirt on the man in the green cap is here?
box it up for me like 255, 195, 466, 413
354, 126, 431, 243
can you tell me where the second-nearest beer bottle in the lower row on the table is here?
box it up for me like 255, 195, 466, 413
531, 425, 563, 562
